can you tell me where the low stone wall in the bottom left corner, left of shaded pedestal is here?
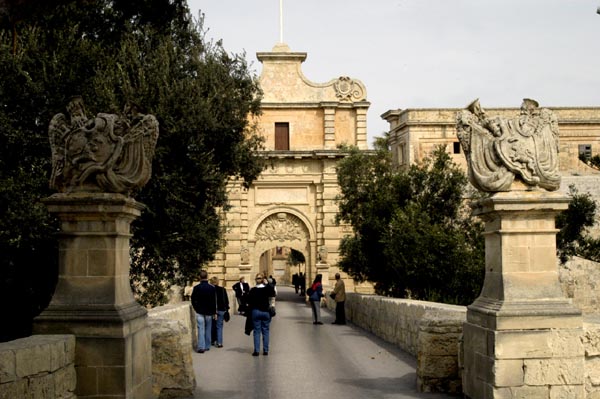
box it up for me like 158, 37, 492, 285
0, 335, 77, 399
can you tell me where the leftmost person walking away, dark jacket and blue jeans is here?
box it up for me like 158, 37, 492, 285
192, 270, 217, 353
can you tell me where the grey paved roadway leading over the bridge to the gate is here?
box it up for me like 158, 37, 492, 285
193, 287, 456, 399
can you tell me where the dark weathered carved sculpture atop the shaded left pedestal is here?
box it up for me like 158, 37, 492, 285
48, 97, 159, 195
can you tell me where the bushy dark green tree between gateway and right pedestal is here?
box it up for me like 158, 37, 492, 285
338, 137, 484, 304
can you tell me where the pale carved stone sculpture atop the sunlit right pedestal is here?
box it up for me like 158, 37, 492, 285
457, 99, 560, 192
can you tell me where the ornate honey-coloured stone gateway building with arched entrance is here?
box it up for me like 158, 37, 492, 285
209, 43, 370, 289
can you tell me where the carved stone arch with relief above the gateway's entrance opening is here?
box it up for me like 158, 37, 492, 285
248, 208, 316, 284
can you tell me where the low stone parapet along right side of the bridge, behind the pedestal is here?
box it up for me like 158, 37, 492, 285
327, 293, 467, 393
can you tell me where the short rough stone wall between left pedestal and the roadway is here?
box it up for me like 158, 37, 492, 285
148, 302, 197, 399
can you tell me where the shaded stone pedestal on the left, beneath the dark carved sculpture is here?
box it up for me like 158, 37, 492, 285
34, 193, 153, 399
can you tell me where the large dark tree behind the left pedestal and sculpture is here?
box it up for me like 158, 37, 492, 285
0, 0, 262, 338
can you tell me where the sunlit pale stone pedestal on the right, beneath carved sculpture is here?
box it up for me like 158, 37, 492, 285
463, 191, 584, 399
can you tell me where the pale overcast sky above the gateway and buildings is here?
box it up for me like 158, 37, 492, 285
188, 0, 600, 145
